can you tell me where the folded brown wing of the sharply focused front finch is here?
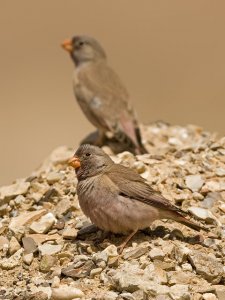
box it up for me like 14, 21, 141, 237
107, 164, 187, 214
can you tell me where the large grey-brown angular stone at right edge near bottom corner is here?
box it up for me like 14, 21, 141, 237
188, 251, 224, 284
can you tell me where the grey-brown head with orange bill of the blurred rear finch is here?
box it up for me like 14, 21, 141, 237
62, 35, 106, 65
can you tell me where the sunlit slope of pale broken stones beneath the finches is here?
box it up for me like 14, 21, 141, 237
0, 123, 225, 300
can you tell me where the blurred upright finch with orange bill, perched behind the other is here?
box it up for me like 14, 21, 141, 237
62, 36, 147, 154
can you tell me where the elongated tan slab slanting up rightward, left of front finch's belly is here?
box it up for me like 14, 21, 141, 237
9, 209, 46, 234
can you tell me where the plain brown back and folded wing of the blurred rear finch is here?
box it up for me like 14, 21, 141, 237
75, 63, 138, 145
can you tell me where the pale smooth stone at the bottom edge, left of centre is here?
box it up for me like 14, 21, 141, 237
51, 284, 84, 300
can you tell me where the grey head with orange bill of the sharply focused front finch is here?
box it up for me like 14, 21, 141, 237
68, 144, 114, 180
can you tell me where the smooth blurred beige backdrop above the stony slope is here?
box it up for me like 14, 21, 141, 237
0, 0, 225, 185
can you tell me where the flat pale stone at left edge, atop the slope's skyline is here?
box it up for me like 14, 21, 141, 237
0, 180, 30, 199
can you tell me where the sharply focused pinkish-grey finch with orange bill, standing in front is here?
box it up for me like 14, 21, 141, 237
69, 145, 206, 252
